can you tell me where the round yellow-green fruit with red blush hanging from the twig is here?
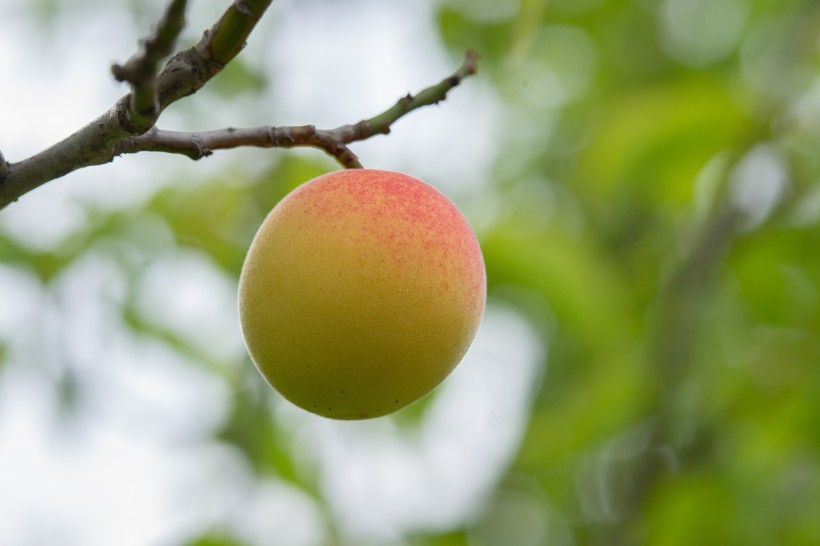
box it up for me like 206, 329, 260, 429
239, 169, 486, 419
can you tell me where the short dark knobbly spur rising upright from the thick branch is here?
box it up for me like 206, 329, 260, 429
111, 0, 187, 129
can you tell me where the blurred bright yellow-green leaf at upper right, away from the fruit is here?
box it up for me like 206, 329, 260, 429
576, 75, 749, 218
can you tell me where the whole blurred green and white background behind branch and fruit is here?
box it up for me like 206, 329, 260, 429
0, 0, 820, 546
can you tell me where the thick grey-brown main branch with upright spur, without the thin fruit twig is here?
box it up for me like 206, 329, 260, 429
0, 0, 278, 209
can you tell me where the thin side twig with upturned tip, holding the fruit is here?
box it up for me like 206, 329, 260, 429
114, 51, 479, 168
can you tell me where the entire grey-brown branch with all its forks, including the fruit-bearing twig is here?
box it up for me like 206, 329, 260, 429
0, 0, 479, 209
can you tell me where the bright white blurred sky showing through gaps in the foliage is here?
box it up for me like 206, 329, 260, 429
0, 0, 542, 546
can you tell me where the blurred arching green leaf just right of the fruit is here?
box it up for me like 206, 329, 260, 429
482, 217, 652, 467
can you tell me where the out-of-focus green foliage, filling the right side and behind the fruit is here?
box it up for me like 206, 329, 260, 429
0, 0, 820, 546
